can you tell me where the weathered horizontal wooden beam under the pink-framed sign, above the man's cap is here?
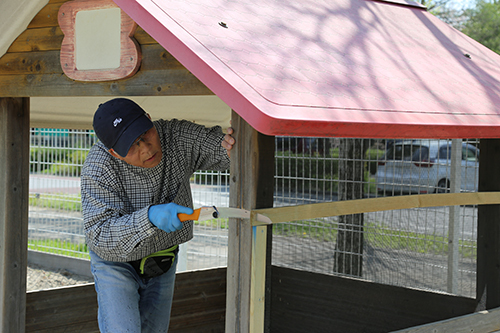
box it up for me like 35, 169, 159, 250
0, 44, 213, 97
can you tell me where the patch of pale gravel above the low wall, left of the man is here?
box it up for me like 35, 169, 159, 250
26, 264, 94, 291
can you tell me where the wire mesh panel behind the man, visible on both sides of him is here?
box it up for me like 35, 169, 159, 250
29, 128, 229, 270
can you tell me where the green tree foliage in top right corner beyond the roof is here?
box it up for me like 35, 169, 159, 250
462, 0, 500, 53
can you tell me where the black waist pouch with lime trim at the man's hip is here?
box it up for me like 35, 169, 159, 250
129, 245, 179, 279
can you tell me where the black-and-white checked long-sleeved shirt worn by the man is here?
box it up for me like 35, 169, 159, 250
81, 119, 229, 262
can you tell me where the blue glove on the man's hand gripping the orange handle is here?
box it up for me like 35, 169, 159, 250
148, 202, 193, 232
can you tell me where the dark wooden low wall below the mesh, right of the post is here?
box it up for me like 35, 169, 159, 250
271, 266, 475, 333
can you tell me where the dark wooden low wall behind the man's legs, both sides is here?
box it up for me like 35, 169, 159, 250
26, 268, 226, 333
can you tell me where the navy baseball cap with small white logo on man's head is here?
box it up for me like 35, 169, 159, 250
92, 98, 153, 157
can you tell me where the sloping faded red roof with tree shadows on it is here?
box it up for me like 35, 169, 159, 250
115, 0, 500, 138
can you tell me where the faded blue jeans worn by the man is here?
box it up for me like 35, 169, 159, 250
90, 251, 177, 333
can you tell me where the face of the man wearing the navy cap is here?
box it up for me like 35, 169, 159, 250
110, 126, 162, 168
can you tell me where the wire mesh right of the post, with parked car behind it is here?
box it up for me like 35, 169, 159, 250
272, 138, 479, 297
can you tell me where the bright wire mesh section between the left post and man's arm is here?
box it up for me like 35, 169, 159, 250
28, 129, 96, 258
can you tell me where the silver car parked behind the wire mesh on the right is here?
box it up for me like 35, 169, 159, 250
375, 140, 479, 194
